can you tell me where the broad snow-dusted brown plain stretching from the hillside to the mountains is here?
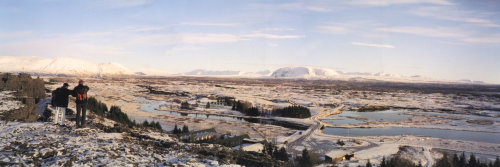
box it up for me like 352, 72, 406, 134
46, 77, 500, 166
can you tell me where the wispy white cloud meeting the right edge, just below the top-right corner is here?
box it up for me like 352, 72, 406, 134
410, 6, 500, 27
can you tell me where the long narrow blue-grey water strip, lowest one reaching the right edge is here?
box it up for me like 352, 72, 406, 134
323, 128, 500, 144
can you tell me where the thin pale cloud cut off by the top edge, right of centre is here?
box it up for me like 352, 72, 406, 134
348, 0, 454, 6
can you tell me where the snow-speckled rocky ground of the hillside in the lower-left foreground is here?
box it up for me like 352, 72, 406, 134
0, 122, 243, 166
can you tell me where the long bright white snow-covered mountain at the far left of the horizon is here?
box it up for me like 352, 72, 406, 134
0, 56, 135, 76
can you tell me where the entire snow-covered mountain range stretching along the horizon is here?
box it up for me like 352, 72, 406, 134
0, 56, 483, 84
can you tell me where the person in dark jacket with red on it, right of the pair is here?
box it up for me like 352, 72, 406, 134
73, 80, 89, 128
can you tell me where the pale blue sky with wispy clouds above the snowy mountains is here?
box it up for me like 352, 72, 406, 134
0, 0, 500, 83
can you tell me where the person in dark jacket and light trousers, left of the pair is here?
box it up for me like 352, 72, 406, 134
52, 83, 73, 126
